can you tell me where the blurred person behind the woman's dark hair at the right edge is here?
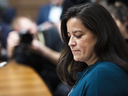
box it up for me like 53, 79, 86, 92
107, 1, 128, 43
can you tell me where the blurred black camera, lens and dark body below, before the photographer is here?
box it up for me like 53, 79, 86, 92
13, 30, 33, 64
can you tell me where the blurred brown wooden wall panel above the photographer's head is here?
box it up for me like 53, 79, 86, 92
9, 0, 49, 20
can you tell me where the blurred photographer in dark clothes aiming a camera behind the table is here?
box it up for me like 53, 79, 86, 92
7, 16, 62, 92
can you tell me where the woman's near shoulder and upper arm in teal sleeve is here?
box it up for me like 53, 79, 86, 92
85, 62, 128, 96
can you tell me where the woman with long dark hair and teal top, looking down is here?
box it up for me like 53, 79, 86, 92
57, 3, 128, 96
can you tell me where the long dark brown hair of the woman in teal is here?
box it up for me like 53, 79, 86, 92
57, 3, 128, 86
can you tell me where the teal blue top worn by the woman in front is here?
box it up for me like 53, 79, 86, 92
68, 60, 128, 96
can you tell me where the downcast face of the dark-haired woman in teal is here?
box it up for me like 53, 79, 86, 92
67, 18, 98, 65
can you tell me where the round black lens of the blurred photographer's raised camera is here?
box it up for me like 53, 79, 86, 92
19, 30, 33, 45
